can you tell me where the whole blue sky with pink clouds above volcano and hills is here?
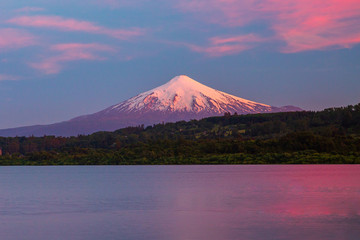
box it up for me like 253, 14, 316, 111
0, 0, 360, 129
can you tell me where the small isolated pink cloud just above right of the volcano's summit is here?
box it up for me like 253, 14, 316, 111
183, 34, 264, 57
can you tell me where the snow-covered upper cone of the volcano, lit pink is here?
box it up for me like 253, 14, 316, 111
107, 75, 271, 114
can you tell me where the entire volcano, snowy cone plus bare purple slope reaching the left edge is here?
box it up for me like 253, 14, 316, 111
0, 75, 302, 136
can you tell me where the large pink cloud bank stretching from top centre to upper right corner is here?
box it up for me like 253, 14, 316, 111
177, 0, 360, 53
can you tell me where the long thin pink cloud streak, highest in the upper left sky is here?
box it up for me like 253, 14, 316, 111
7, 16, 144, 40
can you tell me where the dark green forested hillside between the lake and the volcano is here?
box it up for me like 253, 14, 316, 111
0, 104, 360, 165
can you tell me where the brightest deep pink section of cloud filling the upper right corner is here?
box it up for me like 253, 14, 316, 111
268, 0, 360, 53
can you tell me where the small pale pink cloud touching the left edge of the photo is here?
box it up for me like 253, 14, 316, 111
0, 28, 36, 51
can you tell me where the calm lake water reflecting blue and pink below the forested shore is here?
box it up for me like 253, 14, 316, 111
0, 165, 360, 240
